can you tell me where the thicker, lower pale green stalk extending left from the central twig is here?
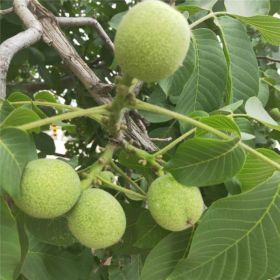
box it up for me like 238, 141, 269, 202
17, 105, 108, 130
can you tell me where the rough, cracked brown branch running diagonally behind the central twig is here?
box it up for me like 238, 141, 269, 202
10, 0, 157, 151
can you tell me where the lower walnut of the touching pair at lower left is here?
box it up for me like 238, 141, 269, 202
68, 189, 126, 249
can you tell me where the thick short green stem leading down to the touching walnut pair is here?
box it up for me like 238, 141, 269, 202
81, 143, 117, 190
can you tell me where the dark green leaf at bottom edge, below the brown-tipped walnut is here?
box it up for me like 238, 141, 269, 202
141, 230, 191, 280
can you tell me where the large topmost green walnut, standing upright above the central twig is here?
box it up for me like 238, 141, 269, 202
115, 0, 191, 82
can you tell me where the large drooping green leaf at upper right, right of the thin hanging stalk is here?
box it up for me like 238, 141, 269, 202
216, 16, 259, 103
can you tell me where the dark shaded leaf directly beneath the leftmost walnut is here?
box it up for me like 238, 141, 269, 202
24, 215, 77, 246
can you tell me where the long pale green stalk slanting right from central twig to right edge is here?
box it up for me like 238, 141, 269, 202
131, 100, 280, 171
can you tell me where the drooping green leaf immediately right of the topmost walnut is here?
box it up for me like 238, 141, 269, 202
176, 29, 227, 115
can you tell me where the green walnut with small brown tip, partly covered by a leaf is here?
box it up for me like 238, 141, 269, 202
147, 175, 204, 231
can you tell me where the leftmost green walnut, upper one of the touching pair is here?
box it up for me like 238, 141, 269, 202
15, 159, 81, 219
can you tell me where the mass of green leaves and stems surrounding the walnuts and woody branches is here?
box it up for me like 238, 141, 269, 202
0, 0, 280, 280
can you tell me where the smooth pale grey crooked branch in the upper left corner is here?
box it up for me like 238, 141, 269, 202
0, 0, 42, 98
